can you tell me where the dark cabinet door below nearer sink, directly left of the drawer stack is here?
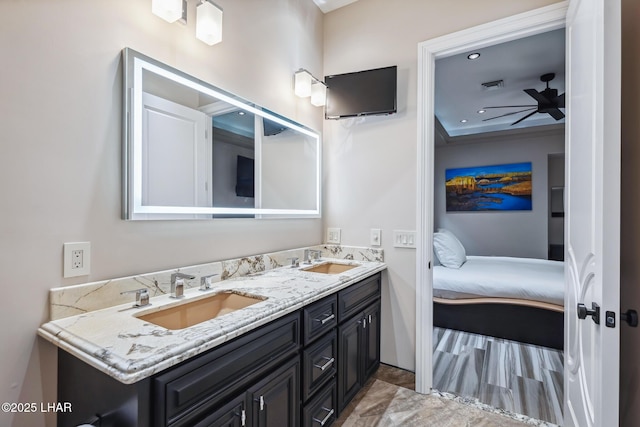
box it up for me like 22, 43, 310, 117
248, 357, 300, 427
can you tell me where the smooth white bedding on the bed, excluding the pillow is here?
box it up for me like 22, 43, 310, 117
433, 256, 564, 306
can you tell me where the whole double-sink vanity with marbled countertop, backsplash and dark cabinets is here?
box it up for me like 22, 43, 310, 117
38, 246, 386, 427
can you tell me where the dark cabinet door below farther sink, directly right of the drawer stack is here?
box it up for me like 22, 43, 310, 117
338, 314, 363, 412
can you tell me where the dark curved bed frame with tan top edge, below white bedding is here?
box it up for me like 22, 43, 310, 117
433, 297, 564, 350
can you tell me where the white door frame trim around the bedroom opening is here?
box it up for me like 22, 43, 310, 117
416, 3, 567, 393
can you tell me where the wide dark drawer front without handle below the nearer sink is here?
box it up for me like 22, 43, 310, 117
158, 313, 301, 426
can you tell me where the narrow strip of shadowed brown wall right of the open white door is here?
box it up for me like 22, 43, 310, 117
620, 0, 640, 427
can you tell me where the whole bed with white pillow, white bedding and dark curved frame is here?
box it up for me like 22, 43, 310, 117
433, 230, 564, 349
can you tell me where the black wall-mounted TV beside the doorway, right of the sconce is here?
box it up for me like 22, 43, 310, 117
324, 65, 398, 119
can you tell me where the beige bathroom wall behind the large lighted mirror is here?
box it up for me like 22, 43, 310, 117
0, 0, 323, 427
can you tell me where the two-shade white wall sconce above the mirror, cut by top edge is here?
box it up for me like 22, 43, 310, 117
151, 0, 222, 46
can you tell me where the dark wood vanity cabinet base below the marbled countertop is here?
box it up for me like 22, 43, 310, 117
58, 273, 380, 427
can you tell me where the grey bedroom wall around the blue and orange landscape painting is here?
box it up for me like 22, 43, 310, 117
434, 129, 564, 259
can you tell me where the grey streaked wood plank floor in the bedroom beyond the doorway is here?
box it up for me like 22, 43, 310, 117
433, 328, 563, 424
